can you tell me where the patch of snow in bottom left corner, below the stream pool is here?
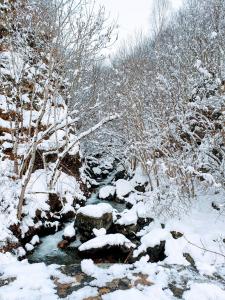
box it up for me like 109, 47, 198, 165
0, 253, 67, 300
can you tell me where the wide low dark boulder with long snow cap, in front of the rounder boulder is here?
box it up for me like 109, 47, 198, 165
78, 233, 136, 259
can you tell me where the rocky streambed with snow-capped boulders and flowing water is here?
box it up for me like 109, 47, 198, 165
24, 158, 225, 300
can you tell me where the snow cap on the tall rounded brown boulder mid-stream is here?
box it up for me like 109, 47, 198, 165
77, 203, 113, 218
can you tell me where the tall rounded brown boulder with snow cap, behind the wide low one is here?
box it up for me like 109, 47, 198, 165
75, 203, 113, 240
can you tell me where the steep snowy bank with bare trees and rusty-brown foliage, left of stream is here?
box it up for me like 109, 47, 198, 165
0, 0, 116, 245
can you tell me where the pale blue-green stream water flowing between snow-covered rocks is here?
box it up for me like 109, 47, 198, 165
28, 172, 124, 265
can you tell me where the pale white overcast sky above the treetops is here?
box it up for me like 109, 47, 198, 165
97, 0, 182, 52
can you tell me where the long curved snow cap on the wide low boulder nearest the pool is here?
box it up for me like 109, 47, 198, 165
79, 233, 135, 251
